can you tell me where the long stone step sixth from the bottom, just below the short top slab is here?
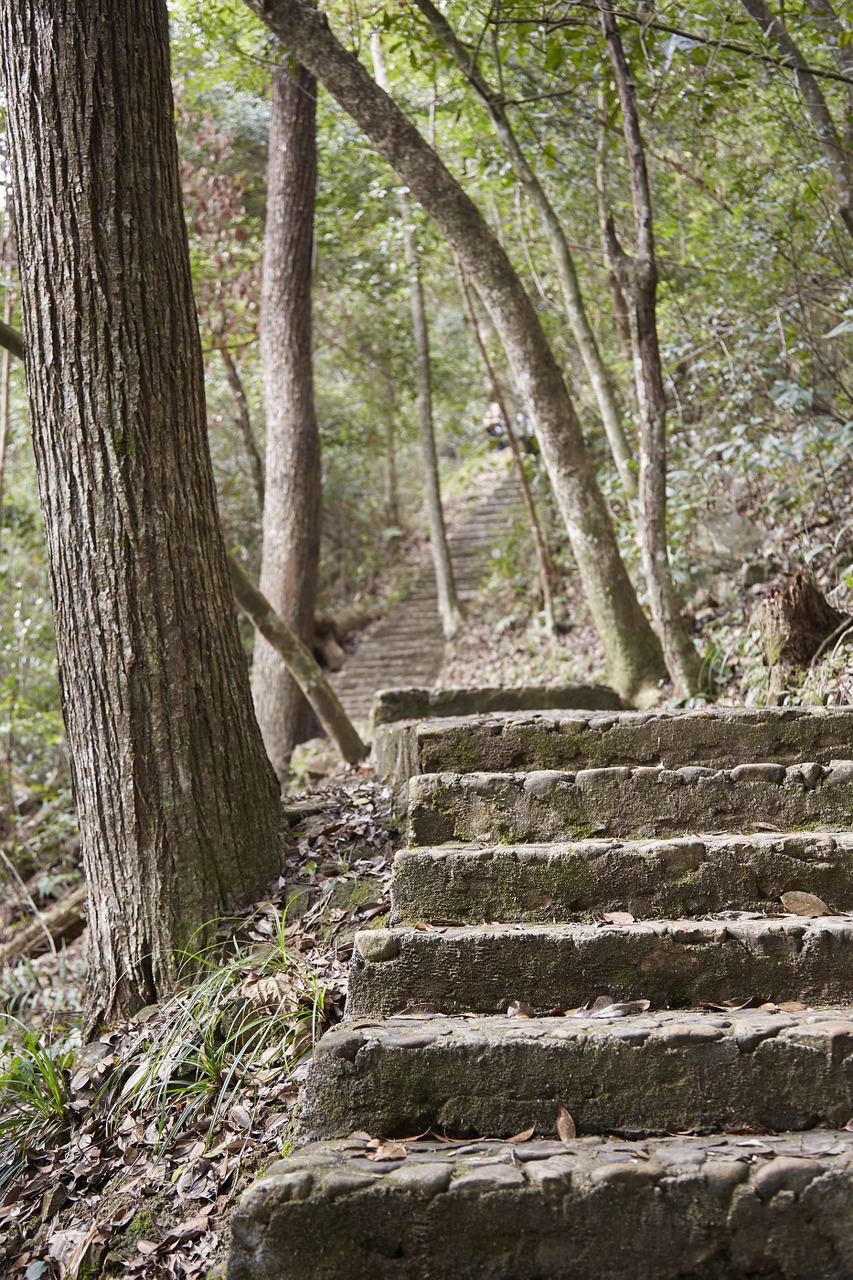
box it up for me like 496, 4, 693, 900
379, 690, 853, 773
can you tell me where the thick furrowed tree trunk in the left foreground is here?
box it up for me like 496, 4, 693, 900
0, 0, 282, 1020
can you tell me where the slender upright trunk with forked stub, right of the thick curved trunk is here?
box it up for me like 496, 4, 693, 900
599, 0, 701, 698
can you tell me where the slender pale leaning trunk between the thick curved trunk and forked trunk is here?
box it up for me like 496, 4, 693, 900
415, 0, 637, 498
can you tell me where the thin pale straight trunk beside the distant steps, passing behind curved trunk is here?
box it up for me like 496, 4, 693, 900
370, 35, 462, 640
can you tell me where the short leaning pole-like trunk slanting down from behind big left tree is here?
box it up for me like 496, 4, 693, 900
228, 556, 368, 764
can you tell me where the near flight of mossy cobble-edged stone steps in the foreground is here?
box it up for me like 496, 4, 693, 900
228, 708, 853, 1280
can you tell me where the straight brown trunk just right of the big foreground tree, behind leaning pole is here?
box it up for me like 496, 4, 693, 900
252, 63, 323, 786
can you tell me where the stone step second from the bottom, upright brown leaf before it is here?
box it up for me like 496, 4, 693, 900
297, 1006, 853, 1143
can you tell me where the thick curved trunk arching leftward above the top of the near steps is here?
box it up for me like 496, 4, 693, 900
240, 0, 662, 700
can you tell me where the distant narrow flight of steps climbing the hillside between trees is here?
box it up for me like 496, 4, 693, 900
333, 467, 523, 722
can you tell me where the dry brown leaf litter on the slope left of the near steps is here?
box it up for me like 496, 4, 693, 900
0, 767, 405, 1280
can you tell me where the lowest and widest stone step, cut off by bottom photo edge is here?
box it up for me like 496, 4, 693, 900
228, 1130, 853, 1280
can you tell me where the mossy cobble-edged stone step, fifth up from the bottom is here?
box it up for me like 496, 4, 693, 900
409, 760, 853, 845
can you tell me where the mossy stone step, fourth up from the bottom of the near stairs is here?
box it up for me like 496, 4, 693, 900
391, 832, 853, 924
